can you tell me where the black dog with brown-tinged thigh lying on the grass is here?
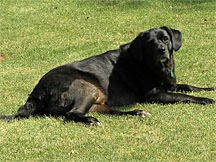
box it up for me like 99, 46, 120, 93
0, 26, 215, 125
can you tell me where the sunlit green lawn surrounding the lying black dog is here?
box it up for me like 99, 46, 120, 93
0, 0, 216, 162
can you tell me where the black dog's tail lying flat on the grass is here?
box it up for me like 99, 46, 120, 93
0, 99, 38, 121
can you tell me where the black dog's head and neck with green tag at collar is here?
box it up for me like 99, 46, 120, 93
128, 26, 182, 90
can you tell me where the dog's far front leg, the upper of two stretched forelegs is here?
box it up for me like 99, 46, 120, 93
176, 84, 216, 92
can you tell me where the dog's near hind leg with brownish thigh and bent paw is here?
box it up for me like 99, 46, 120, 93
60, 79, 104, 126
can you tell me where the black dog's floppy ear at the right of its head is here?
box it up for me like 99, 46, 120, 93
160, 26, 182, 51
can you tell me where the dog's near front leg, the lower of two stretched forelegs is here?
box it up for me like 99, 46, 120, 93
145, 92, 215, 105
